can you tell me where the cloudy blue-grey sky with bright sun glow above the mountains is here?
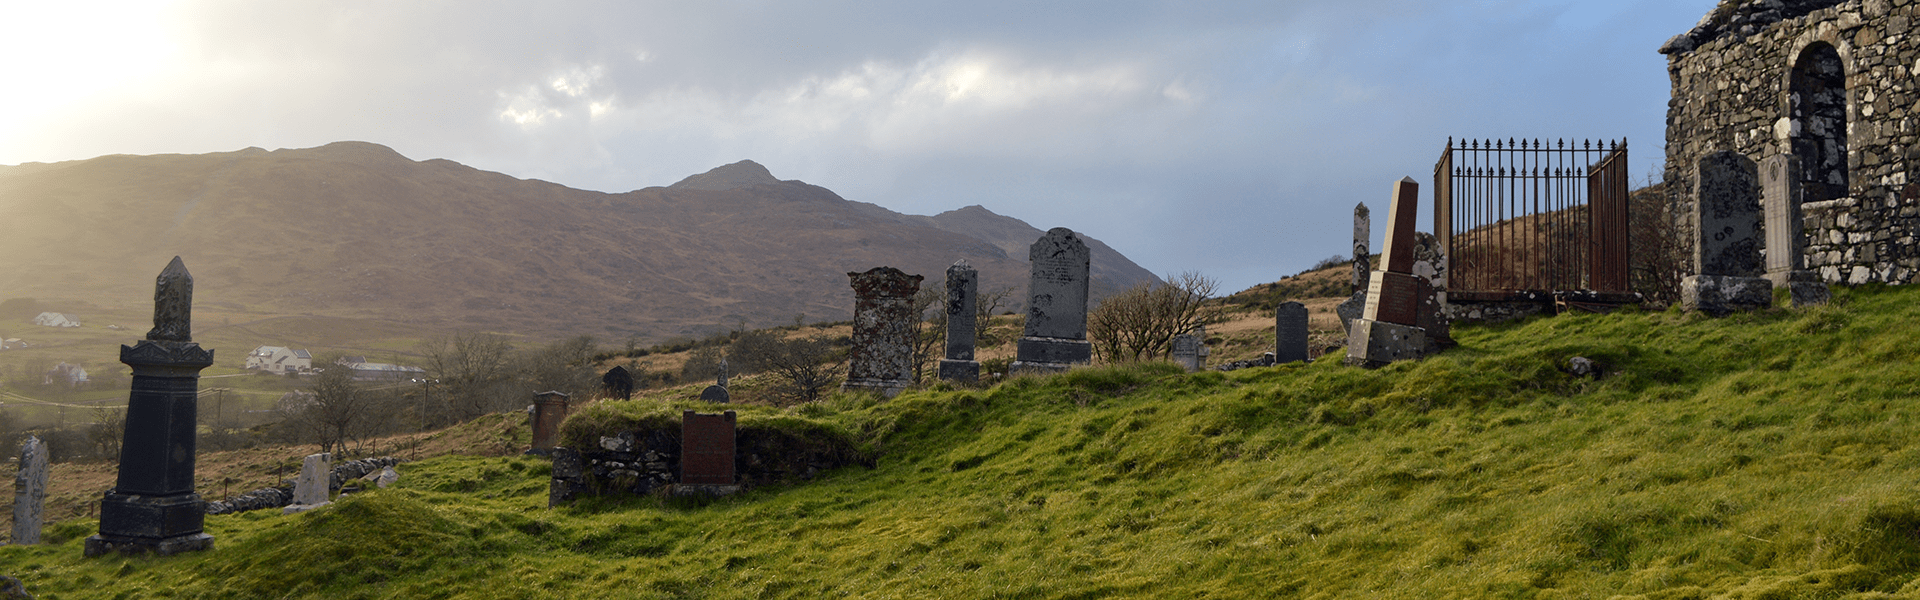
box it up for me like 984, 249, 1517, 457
0, 0, 1715, 292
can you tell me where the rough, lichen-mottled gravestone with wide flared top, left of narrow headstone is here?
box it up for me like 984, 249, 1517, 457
841, 267, 922, 398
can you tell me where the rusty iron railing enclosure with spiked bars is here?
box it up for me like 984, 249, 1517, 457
1434, 138, 1630, 302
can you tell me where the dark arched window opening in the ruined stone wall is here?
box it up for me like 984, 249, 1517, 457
1788, 42, 1847, 202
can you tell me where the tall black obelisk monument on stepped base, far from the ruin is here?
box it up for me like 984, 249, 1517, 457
84, 256, 213, 556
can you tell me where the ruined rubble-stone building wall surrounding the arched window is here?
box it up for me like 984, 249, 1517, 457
1661, 0, 1920, 285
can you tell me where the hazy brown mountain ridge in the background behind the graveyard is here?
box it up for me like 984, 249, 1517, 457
0, 142, 1156, 338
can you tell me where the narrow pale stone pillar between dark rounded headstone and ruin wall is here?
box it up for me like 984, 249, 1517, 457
1761, 154, 1832, 306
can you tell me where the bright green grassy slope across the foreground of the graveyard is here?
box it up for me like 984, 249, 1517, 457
11, 287, 1920, 598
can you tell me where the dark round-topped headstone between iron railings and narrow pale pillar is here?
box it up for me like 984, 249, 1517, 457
1680, 150, 1774, 315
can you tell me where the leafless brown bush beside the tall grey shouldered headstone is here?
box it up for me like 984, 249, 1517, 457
1087, 271, 1221, 362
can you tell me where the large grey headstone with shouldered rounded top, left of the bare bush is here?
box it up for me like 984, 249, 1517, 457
1008, 227, 1092, 373
